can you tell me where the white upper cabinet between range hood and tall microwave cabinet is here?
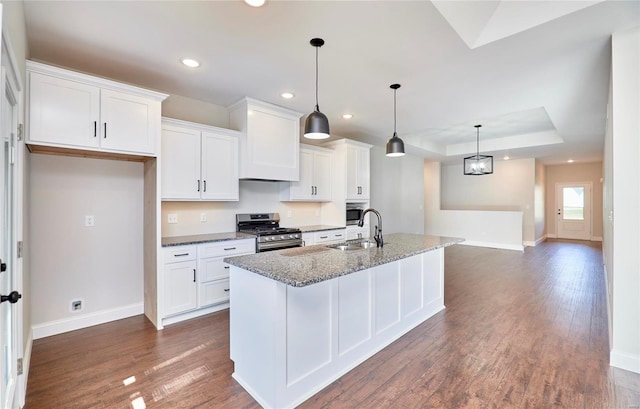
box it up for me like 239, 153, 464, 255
280, 145, 333, 202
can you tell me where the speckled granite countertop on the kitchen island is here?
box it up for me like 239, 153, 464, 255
224, 233, 464, 287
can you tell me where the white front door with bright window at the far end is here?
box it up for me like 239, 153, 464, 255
556, 182, 591, 240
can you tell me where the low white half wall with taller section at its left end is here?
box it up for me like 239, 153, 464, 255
424, 162, 523, 250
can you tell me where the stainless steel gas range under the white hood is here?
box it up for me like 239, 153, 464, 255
236, 213, 302, 253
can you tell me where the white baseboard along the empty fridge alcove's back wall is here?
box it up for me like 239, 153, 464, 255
31, 303, 144, 339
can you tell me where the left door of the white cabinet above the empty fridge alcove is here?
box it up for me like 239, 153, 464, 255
27, 72, 100, 148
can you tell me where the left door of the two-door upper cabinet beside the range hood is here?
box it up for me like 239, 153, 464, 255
162, 125, 202, 200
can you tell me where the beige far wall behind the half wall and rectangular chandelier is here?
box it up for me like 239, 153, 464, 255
440, 159, 536, 245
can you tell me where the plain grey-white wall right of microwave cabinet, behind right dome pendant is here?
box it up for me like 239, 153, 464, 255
369, 146, 424, 236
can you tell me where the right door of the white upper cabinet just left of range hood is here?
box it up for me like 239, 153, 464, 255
201, 132, 240, 201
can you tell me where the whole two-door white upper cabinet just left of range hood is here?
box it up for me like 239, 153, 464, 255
161, 118, 239, 201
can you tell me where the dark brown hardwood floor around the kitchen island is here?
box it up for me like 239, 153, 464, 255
26, 241, 640, 409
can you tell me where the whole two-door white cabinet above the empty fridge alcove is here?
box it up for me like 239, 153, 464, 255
26, 61, 167, 156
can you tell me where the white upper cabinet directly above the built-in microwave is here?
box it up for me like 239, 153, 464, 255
323, 139, 371, 202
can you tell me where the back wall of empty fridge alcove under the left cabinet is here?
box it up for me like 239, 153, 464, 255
29, 155, 143, 338
